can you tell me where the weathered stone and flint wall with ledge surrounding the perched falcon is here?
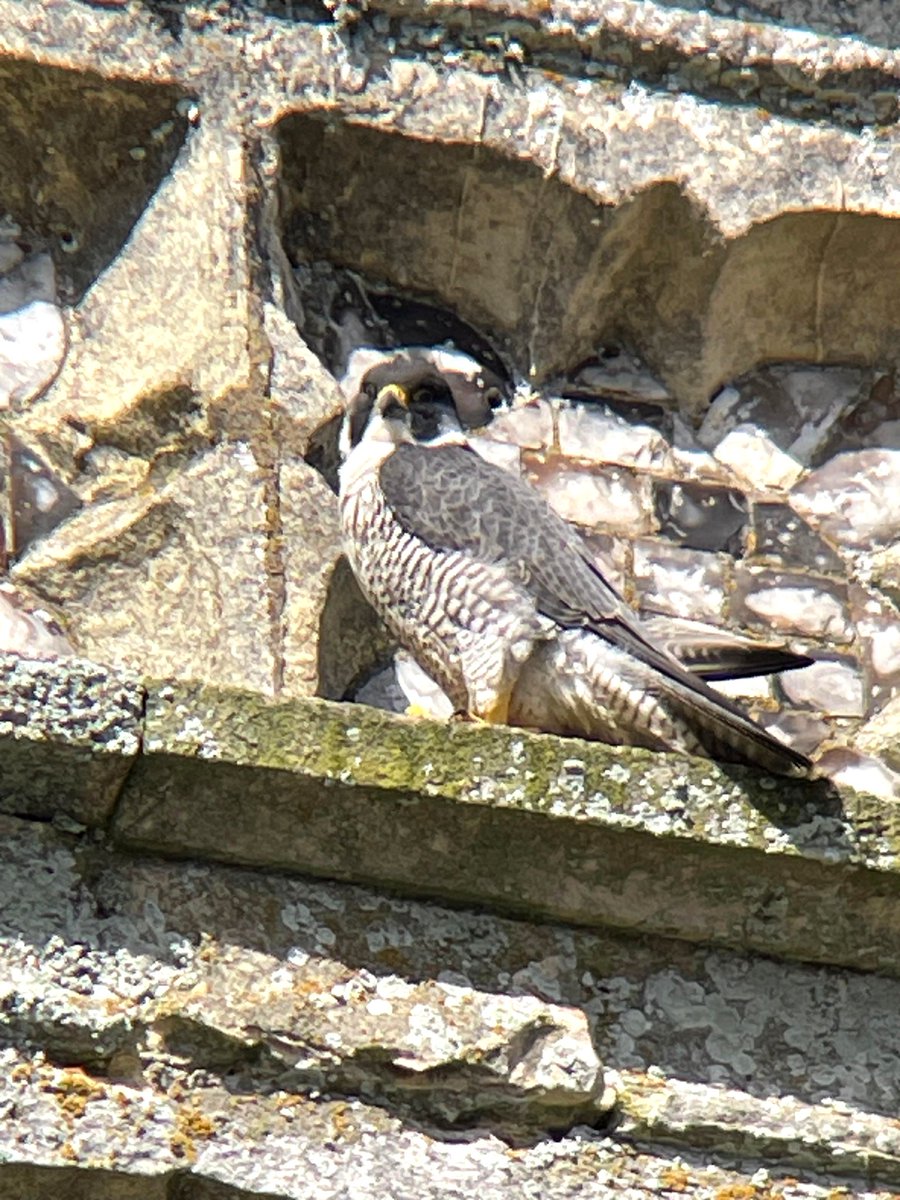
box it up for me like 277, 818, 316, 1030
0, 0, 900, 1200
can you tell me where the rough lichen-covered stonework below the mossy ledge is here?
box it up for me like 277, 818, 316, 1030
0, 817, 900, 1200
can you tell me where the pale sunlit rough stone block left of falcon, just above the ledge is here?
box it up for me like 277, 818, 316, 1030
12, 444, 280, 692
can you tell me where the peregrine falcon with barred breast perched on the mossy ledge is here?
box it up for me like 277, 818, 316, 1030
340, 352, 810, 775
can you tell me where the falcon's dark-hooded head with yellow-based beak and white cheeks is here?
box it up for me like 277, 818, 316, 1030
341, 347, 504, 461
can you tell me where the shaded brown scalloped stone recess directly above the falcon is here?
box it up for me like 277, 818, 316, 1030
277, 114, 900, 415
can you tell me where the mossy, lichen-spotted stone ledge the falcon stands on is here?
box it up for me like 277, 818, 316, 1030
0, 656, 900, 974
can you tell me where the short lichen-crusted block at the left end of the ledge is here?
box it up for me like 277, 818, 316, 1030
0, 653, 144, 824
